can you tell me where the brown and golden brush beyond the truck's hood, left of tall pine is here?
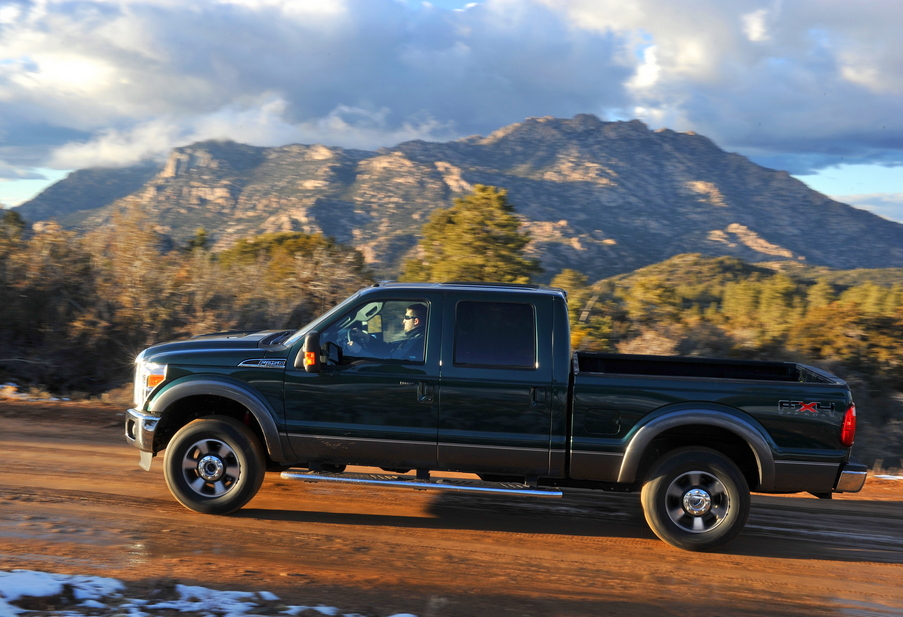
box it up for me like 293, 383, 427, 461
0, 210, 371, 393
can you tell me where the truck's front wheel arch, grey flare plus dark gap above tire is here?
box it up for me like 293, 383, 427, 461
147, 378, 290, 461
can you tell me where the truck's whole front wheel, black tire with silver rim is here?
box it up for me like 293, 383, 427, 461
163, 416, 266, 514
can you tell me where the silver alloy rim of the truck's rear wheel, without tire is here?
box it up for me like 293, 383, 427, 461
666, 471, 730, 533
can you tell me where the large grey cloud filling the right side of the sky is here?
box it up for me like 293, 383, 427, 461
547, 0, 903, 170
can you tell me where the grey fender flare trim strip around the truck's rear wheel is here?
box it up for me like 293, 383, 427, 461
618, 409, 774, 491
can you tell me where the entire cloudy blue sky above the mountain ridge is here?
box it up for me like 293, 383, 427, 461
0, 0, 903, 222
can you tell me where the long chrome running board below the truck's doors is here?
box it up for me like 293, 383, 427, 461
282, 471, 561, 497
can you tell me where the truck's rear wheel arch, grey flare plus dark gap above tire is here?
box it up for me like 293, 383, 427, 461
618, 408, 775, 491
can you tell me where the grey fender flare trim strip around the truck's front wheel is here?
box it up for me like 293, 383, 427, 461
147, 378, 291, 461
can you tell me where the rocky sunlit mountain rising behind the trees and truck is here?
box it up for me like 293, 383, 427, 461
14, 115, 903, 280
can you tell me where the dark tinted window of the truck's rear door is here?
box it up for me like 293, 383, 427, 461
455, 302, 536, 369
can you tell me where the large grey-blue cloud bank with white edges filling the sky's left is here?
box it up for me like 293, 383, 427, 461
0, 0, 632, 167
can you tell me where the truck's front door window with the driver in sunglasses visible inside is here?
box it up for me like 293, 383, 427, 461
320, 300, 429, 363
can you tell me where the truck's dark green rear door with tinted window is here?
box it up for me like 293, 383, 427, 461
439, 293, 553, 475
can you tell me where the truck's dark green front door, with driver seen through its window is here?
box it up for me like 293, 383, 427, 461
285, 292, 441, 468
